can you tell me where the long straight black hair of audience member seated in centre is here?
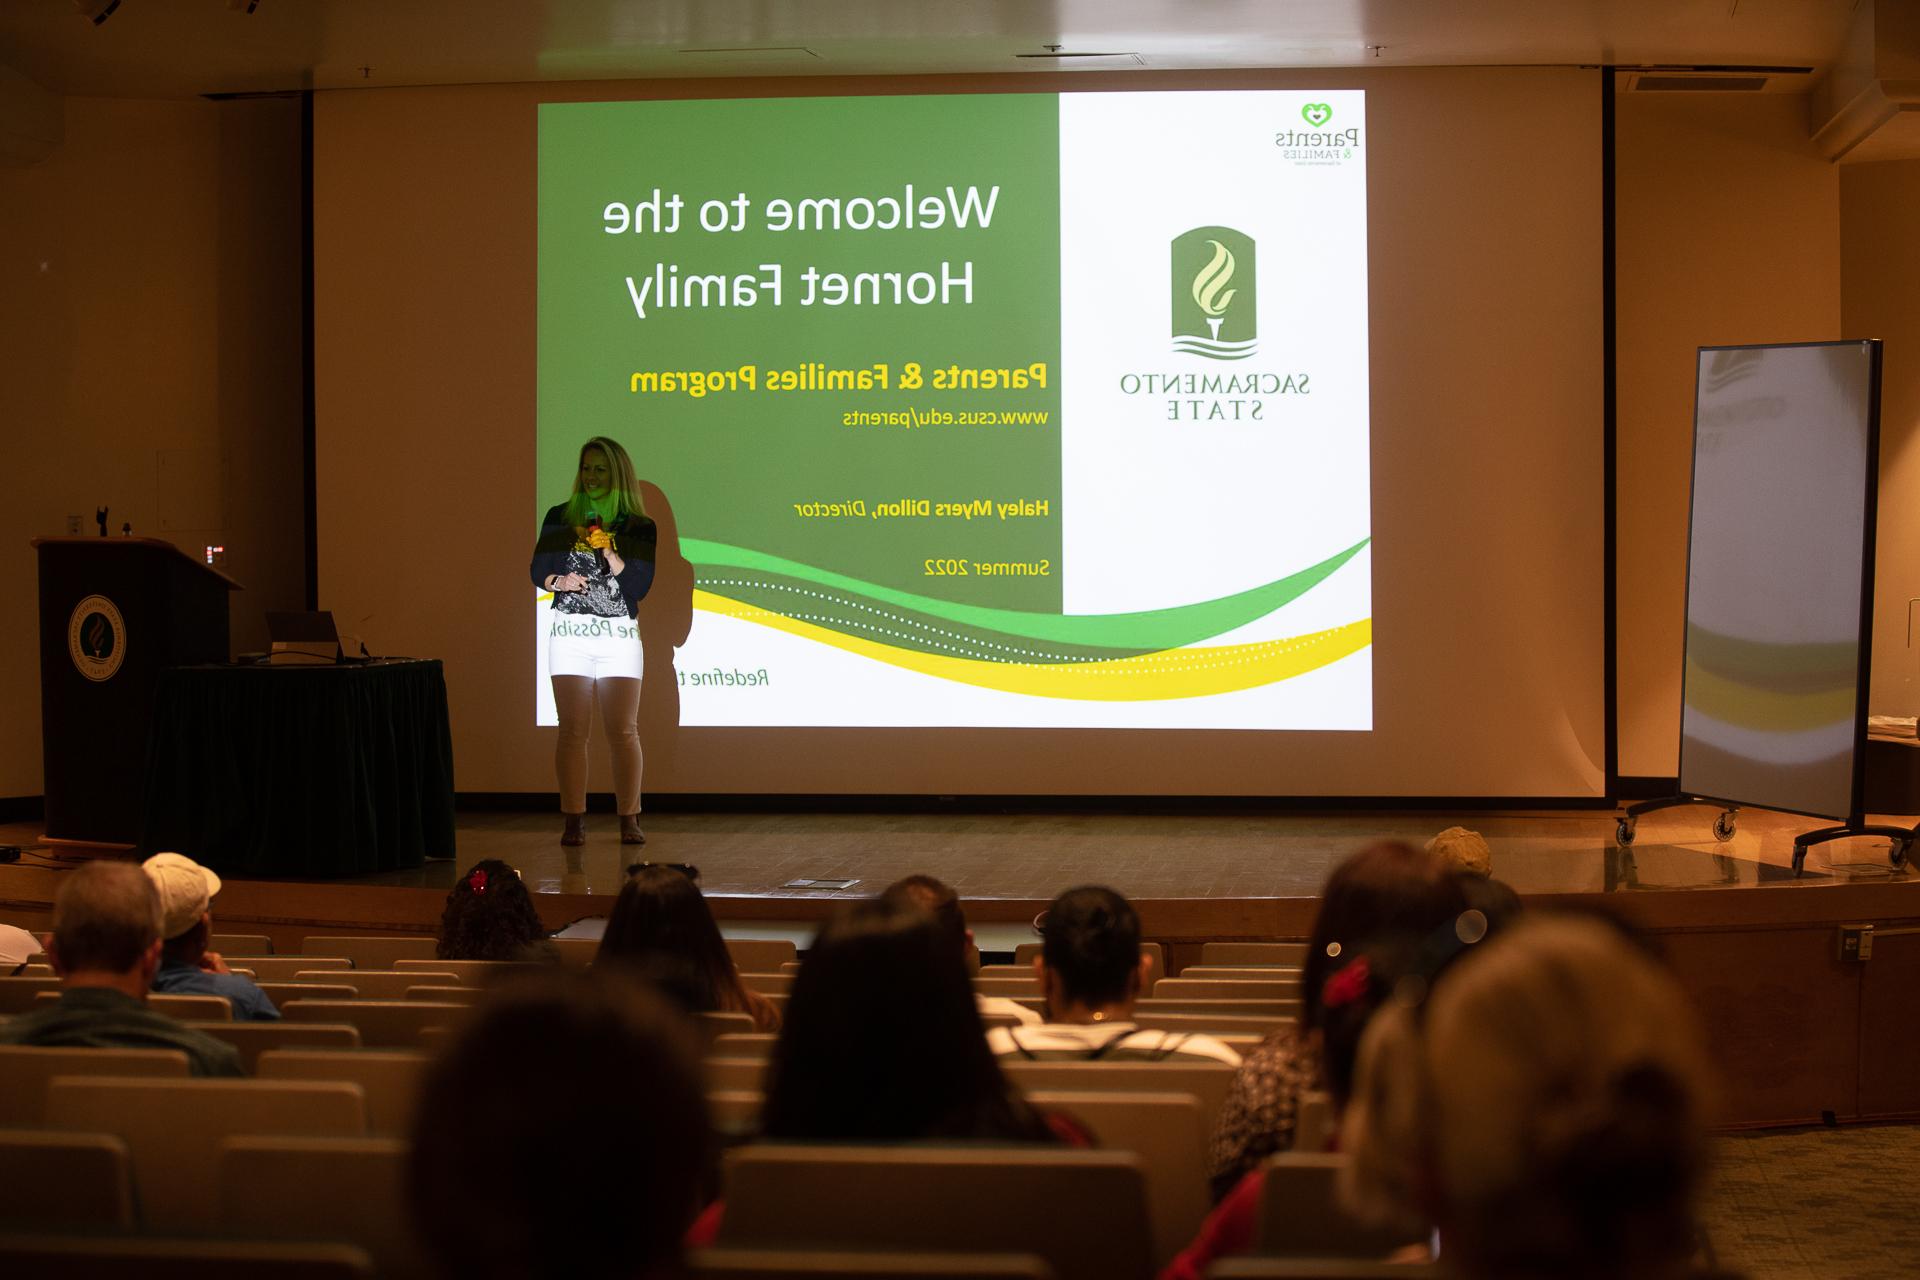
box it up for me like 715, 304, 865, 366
760, 898, 1046, 1142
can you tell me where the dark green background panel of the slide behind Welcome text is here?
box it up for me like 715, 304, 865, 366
536, 94, 1062, 612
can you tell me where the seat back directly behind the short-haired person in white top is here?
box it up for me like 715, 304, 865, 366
1027, 1090, 1212, 1270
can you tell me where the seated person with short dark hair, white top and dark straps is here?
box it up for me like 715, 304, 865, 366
987, 885, 1240, 1067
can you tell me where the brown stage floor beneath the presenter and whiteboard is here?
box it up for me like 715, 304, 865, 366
0, 806, 1912, 900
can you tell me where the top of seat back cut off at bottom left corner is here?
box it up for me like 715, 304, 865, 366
0, 1236, 374, 1280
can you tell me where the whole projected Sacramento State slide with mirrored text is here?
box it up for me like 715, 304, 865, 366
528, 90, 1373, 729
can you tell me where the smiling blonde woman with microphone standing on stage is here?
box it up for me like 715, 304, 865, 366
532, 436, 659, 844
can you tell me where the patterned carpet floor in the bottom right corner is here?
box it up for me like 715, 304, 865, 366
1703, 1125, 1920, 1280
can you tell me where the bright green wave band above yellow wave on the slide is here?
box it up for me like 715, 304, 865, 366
680, 537, 1373, 651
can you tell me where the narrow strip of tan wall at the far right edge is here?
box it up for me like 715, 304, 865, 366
1839, 159, 1920, 729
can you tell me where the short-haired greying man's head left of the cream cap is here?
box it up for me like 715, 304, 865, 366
46, 862, 161, 996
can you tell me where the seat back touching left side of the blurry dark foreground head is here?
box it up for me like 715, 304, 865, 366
219, 1134, 428, 1280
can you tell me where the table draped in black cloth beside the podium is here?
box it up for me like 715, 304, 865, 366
142, 658, 453, 875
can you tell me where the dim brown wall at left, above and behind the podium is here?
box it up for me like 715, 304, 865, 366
0, 98, 305, 798
